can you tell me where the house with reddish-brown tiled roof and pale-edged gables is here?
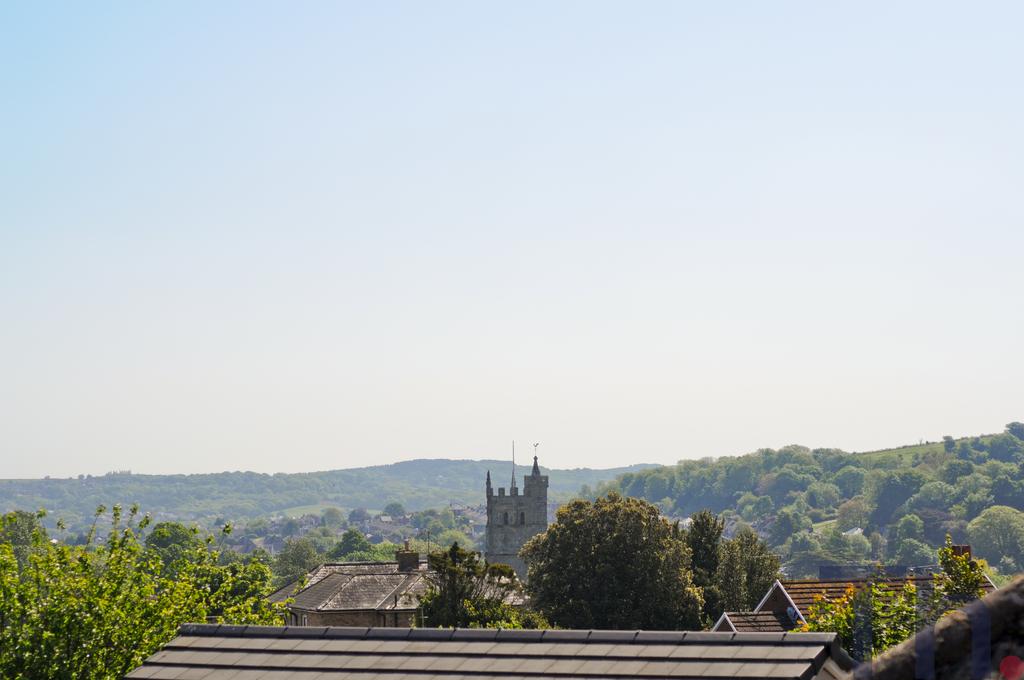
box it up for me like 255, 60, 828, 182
712, 576, 995, 633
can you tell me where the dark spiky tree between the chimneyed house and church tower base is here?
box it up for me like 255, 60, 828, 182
417, 543, 543, 628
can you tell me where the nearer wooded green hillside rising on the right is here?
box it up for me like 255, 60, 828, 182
588, 423, 1024, 575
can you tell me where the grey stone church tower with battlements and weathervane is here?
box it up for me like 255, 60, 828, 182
484, 456, 548, 581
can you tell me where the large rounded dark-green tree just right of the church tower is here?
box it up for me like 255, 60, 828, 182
519, 493, 703, 630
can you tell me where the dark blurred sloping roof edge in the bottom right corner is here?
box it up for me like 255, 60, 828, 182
852, 577, 1024, 680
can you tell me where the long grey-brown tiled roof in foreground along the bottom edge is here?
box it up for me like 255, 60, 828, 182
127, 624, 853, 680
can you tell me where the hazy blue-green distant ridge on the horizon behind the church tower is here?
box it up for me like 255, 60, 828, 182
0, 460, 654, 532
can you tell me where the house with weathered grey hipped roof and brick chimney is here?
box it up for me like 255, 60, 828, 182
269, 550, 428, 628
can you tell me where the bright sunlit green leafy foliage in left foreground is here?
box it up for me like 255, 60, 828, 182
0, 506, 282, 680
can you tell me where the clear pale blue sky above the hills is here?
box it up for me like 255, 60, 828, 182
0, 1, 1024, 477
